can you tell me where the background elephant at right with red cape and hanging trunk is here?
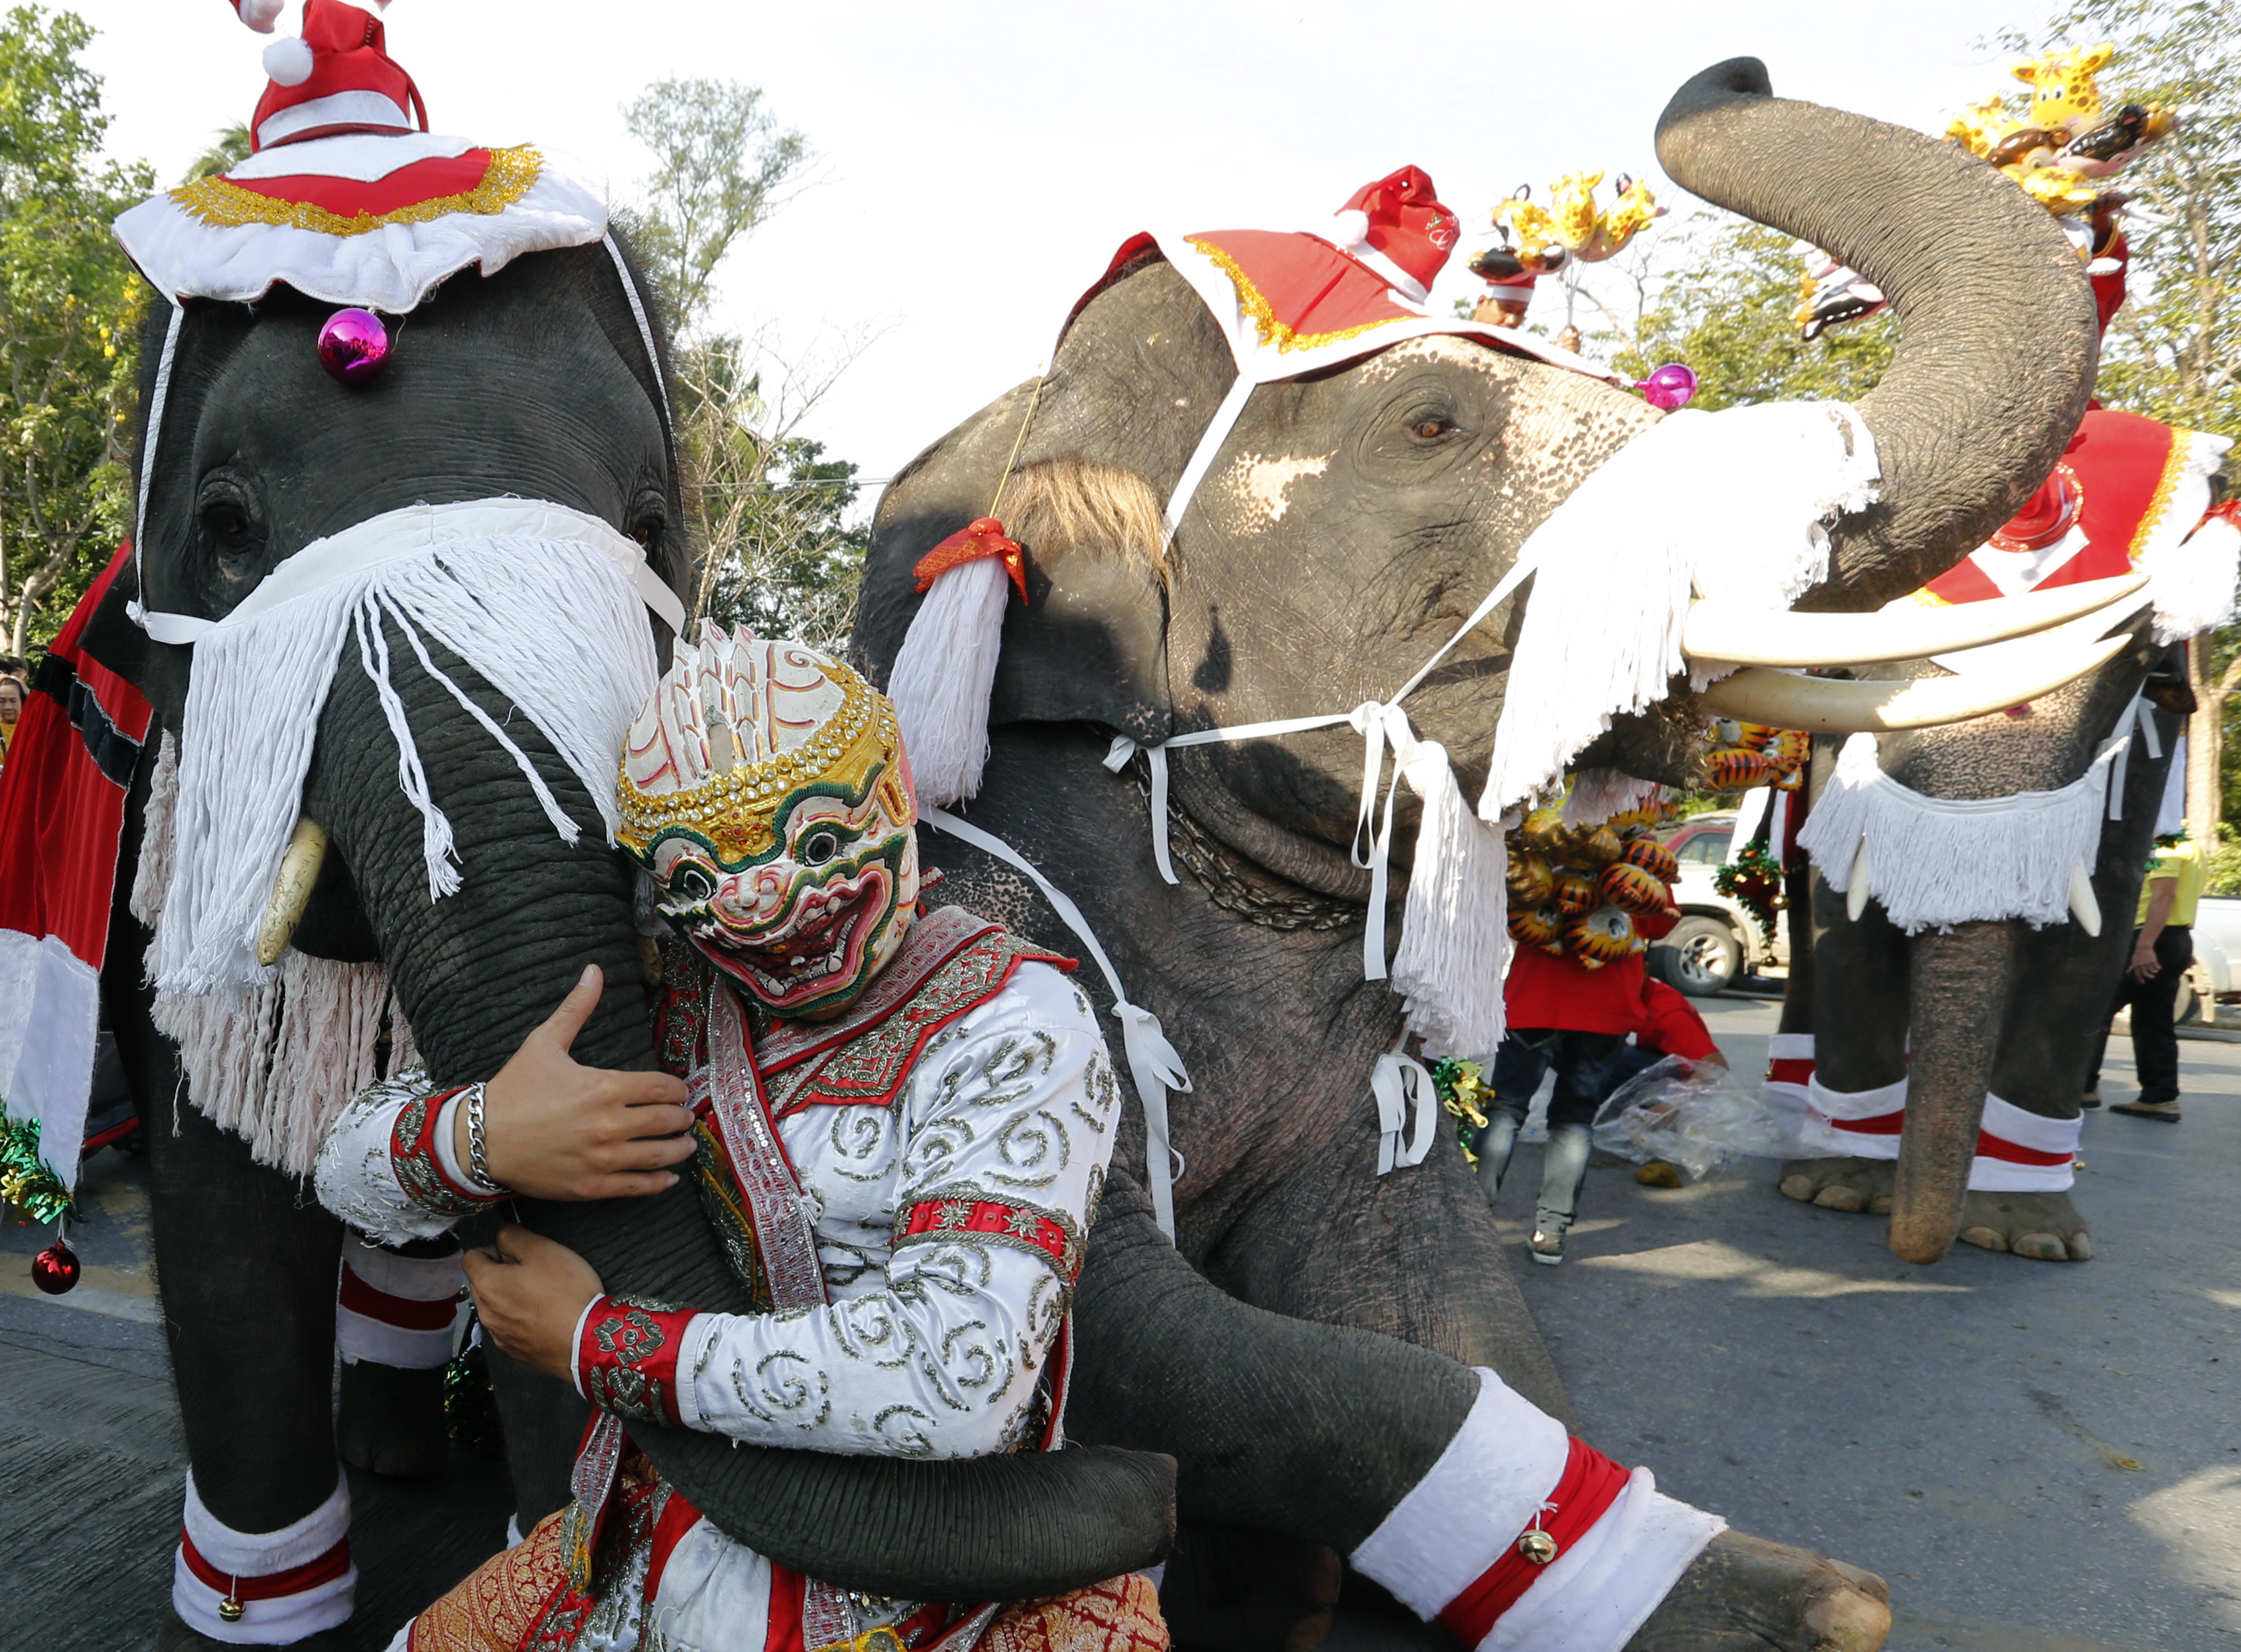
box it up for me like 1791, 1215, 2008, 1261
1772, 410, 2232, 1262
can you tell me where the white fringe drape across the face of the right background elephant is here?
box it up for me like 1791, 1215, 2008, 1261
1798, 736, 2127, 935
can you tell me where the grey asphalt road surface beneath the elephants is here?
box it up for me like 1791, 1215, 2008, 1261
0, 1000, 2241, 1652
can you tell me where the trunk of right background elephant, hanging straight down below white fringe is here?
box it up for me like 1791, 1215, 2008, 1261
1892, 919, 2019, 1264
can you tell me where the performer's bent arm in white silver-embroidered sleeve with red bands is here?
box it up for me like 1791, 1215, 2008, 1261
513, 964, 1121, 1457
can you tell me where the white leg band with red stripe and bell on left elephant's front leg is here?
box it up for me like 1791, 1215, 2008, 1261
170, 1472, 359, 1645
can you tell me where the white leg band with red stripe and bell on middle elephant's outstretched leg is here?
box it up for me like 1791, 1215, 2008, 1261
1349, 1370, 1728, 1652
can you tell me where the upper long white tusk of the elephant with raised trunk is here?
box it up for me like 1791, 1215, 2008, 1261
1681, 574, 2147, 666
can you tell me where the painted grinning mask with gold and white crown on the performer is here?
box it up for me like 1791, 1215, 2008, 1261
616, 623, 919, 1015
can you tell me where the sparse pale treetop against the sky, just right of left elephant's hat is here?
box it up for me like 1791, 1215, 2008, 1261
623, 81, 809, 334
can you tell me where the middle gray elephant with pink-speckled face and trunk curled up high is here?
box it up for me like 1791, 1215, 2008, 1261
856, 51, 2093, 1641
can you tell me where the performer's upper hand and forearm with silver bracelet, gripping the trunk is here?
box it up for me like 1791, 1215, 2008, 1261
314, 968, 693, 1242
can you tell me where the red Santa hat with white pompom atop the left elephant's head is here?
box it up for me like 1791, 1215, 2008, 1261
233, 0, 428, 150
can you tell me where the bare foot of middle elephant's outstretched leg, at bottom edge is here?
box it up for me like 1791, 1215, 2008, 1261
1627, 1531, 1892, 1652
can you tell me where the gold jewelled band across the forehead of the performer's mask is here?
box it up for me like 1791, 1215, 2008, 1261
614, 661, 910, 865
